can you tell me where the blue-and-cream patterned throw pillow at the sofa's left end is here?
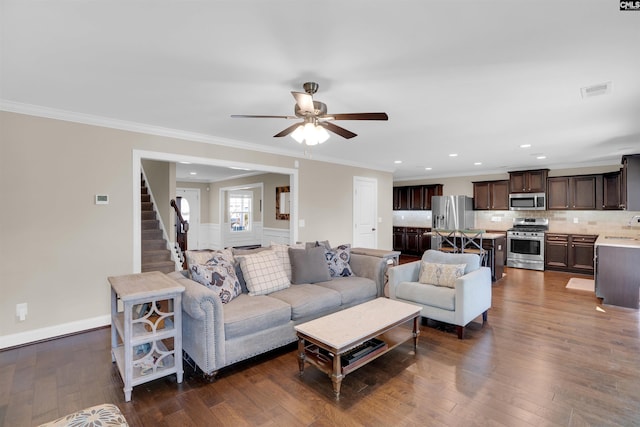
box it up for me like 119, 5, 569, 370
189, 252, 242, 304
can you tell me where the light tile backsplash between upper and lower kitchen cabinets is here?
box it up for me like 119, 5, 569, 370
393, 211, 640, 237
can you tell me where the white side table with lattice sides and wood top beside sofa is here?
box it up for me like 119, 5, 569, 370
108, 271, 184, 402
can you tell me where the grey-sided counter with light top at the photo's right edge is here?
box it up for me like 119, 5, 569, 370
595, 235, 640, 309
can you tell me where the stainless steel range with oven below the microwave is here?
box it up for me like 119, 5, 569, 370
507, 218, 549, 271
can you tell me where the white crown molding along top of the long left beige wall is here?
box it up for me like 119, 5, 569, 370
0, 99, 393, 173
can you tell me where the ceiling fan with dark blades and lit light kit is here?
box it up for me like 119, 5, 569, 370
231, 82, 389, 145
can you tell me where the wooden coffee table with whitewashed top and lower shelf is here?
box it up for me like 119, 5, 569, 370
295, 298, 420, 399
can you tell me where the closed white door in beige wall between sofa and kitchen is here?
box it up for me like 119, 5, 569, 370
353, 176, 378, 249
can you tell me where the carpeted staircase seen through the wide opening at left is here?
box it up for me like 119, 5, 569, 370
140, 178, 176, 273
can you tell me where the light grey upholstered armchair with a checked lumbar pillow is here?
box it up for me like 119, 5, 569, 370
389, 250, 491, 339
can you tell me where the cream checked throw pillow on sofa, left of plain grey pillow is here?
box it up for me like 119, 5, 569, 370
237, 250, 291, 296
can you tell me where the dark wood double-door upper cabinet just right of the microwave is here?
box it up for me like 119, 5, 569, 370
547, 175, 602, 210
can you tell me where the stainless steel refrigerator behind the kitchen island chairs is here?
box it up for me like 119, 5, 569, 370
431, 196, 475, 230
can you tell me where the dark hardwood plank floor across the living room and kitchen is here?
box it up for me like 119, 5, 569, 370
0, 269, 640, 426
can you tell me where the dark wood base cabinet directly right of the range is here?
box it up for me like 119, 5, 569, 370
545, 233, 598, 274
